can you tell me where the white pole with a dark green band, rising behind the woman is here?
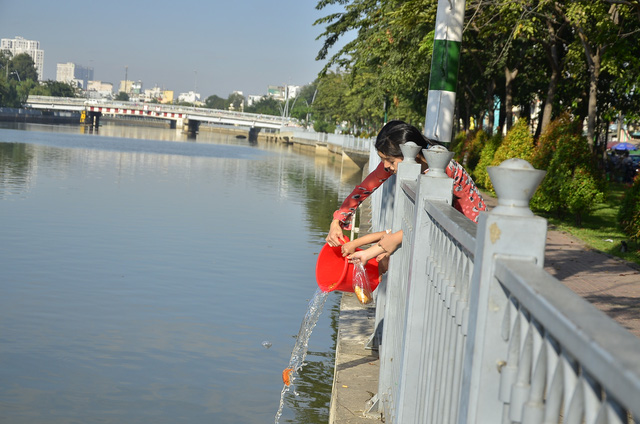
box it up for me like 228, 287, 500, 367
424, 0, 465, 143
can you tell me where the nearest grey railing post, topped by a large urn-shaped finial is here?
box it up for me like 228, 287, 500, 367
458, 159, 547, 424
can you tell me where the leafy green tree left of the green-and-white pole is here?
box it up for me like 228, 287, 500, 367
315, 0, 435, 131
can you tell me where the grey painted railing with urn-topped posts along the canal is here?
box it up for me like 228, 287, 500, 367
364, 151, 640, 424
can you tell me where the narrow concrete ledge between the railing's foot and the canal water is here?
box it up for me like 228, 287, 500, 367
329, 293, 381, 424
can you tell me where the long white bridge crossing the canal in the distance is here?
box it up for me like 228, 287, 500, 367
26, 96, 292, 134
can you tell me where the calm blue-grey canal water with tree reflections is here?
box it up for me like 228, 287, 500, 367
0, 124, 361, 424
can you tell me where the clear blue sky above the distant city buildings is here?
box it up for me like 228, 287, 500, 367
0, 0, 350, 100
